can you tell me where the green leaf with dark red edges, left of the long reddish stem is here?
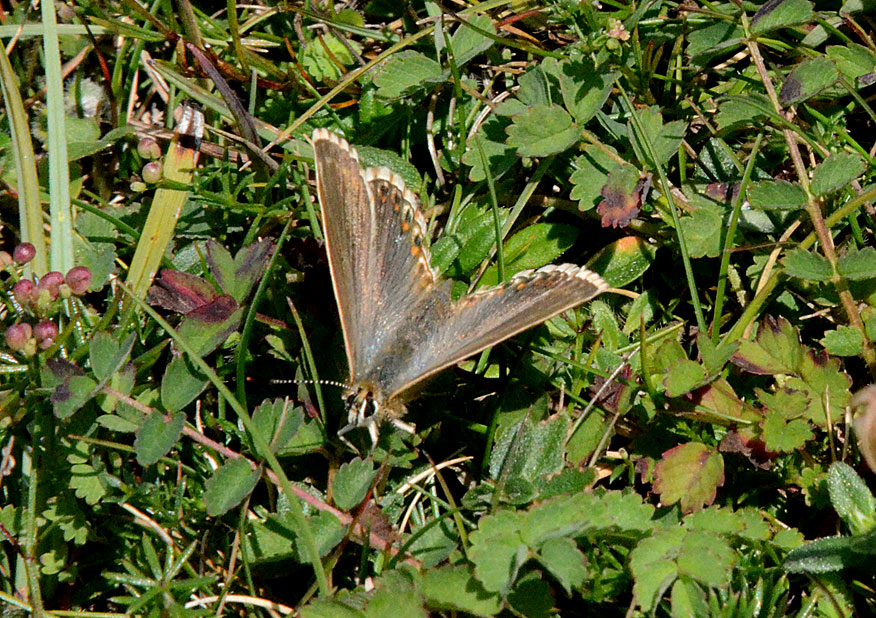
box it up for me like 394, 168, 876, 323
732, 316, 803, 375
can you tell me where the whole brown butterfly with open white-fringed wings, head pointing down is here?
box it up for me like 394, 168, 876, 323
311, 129, 609, 444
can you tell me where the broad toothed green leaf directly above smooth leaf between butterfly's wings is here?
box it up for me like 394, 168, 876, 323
505, 105, 580, 157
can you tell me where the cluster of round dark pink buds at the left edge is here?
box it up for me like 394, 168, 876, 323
0, 243, 92, 357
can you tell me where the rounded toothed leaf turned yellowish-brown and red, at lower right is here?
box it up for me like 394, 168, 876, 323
654, 442, 724, 513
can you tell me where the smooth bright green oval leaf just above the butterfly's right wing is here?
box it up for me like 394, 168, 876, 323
478, 223, 579, 288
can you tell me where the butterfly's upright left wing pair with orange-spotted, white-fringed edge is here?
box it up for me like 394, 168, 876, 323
312, 129, 436, 384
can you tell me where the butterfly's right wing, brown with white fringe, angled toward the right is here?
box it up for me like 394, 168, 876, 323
386, 264, 608, 397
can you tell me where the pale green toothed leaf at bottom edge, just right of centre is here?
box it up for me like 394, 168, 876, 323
422, 566, 502, 616
